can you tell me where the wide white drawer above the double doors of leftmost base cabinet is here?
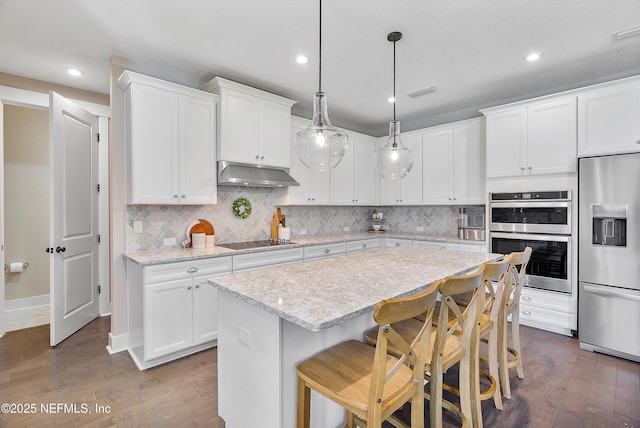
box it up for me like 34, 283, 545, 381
144, 256, 231, 284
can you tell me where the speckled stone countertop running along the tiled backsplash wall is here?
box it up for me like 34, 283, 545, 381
124, 232, 485, 265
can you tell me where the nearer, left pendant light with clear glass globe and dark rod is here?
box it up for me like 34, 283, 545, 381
295, 0, 349, 170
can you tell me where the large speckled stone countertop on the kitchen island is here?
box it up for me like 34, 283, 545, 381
209, 246, 502, 331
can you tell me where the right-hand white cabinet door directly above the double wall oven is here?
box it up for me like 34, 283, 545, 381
526, 97, 578, 175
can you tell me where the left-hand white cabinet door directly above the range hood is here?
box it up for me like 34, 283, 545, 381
218, 89, 260, 164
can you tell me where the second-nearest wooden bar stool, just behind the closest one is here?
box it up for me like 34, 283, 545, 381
366, 265, 484, 427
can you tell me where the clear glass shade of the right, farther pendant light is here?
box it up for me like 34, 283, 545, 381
373, 120, 414, 179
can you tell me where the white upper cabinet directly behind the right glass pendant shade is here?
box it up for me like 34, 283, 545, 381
380, 133, 422, 205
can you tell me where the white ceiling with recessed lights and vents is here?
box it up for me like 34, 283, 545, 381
0, 0, 640, 135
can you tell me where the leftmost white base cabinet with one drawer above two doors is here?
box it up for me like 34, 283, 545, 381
127, 256, 232, 369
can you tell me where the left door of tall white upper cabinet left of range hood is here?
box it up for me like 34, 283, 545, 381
127, 83, 179, 204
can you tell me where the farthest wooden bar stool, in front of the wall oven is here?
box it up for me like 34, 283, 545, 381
498, 247, 532, 398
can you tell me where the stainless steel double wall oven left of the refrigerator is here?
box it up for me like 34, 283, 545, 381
489, 190, 572, 294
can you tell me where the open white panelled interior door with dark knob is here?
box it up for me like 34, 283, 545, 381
48, 92, 99, 346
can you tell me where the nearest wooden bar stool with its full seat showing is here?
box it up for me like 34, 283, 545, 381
297, 284, 438, 428
